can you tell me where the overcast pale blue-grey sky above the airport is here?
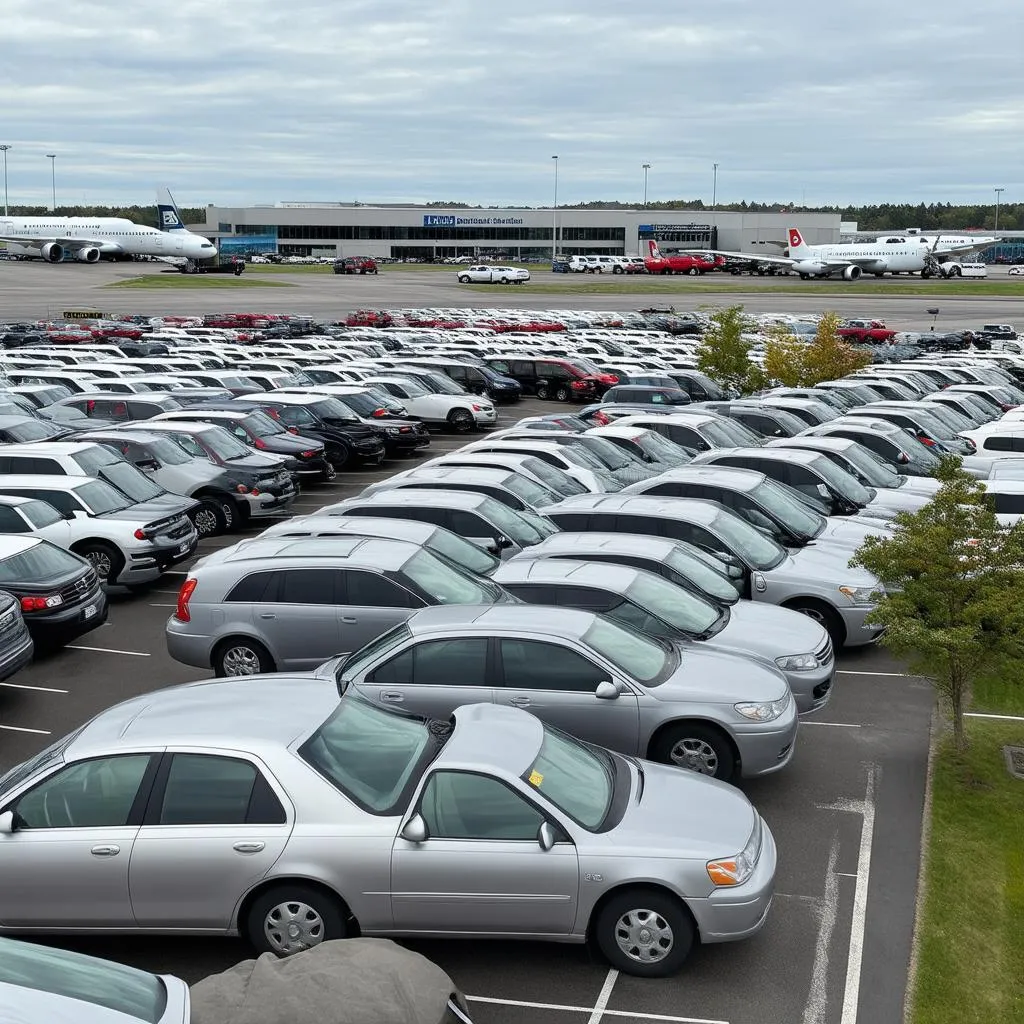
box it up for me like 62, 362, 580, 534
0, 0, 1024, 206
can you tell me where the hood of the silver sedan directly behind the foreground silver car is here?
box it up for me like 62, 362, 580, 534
645, 647, 790, 704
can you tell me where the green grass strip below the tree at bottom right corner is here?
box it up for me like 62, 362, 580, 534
910, 712, 1024, 1024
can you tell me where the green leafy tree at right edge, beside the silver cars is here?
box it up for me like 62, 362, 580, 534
851, 458, 1024, 751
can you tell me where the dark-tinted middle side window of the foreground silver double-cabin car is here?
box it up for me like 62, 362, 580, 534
157, 754, 286, 825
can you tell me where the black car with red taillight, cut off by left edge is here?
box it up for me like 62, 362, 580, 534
0, 535, 106, 647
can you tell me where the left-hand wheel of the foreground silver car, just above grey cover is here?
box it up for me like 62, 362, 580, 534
244, 882, 348, 956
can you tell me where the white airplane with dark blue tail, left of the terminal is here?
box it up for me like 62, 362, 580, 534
0, 188, 217, 263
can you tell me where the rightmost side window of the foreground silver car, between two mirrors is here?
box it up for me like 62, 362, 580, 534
420, 771, 545, 843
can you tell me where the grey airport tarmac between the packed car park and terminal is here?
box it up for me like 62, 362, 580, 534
0, 261, 1024, 331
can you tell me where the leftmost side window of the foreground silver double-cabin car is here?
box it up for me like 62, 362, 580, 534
12, 754, 150, 829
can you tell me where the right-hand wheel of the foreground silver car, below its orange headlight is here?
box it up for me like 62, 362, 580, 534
593, 888, 695, 978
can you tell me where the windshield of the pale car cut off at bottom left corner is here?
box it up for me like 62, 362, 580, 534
0, 939, 167, 1024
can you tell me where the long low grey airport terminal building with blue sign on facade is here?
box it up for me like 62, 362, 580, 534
189, 203, 840, 260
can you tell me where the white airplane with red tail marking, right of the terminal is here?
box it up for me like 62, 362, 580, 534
684, 227, 997, 281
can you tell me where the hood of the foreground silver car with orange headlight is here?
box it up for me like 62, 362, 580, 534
602, 759, 756, 860
